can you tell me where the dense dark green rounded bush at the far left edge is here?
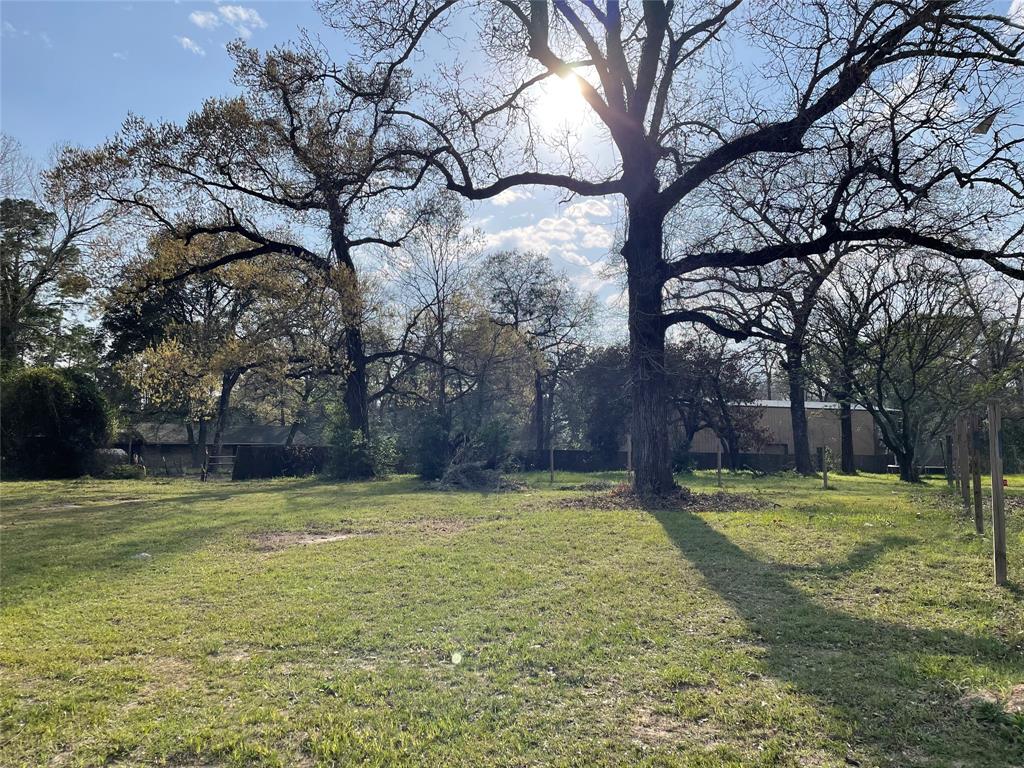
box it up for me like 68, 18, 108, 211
0, 368, 110, 477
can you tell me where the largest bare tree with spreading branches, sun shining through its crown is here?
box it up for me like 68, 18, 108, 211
321, 0, 1024, 494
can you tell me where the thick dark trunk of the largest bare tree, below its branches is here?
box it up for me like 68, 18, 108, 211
623, 203, 676, 496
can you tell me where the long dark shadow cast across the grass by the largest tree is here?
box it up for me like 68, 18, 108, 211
651, 510, 1024, 768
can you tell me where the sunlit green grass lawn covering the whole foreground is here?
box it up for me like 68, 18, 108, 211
0, 474, 1024, 768
